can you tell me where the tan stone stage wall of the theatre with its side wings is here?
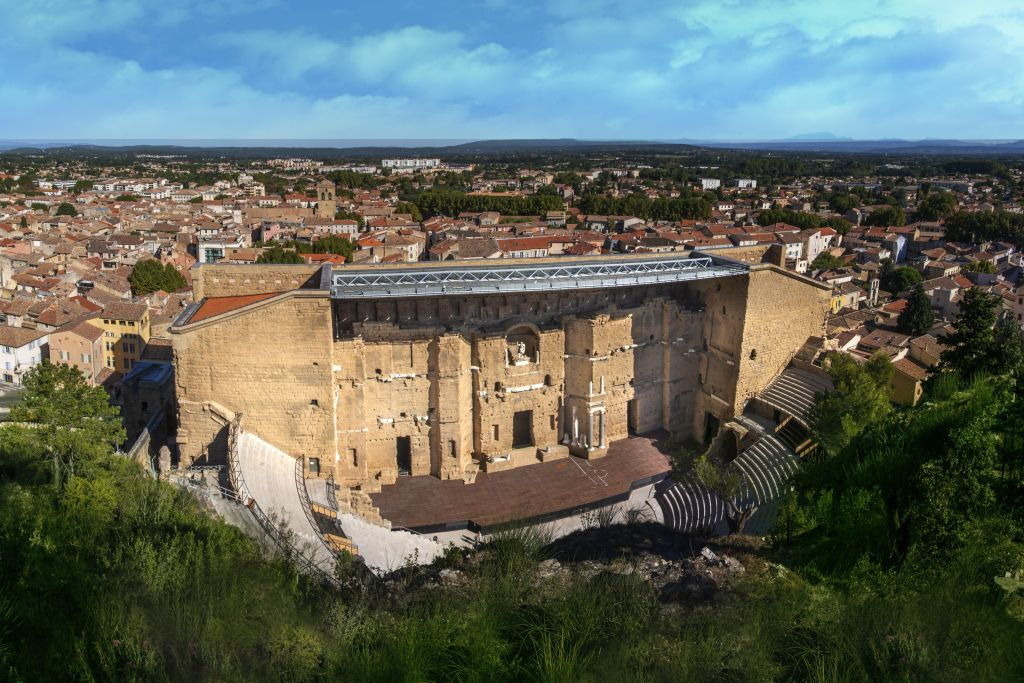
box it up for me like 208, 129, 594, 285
172, 265, 829, 492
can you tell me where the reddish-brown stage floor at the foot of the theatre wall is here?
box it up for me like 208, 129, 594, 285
371, 435, 669, 531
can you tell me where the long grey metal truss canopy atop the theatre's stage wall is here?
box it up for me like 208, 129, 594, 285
331, 256, 750, 299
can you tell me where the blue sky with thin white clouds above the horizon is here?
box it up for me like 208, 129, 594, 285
0, 0, 1024, 139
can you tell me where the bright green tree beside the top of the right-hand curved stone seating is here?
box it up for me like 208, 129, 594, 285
810, 352, 893, 455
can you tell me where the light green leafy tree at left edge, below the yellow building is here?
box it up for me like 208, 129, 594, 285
0, 362, 125, 488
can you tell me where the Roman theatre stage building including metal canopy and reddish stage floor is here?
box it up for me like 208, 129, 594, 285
171, 248, 829, 529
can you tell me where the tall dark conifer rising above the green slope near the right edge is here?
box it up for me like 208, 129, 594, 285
939, 287, 1001, 380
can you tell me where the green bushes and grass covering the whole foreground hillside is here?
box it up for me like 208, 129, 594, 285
0, 369, 1024, 682
